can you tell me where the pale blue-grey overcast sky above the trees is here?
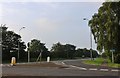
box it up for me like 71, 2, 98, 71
0, 2, 102, 49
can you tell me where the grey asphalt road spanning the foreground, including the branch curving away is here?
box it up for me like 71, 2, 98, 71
2, 60, 119, 76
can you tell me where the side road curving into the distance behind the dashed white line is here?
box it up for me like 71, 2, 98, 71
53, 59, 120, 73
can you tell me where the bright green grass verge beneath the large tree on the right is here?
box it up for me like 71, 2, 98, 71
83, 58, 120, 68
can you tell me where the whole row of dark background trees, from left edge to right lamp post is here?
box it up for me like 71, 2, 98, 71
1, 25, 98, 62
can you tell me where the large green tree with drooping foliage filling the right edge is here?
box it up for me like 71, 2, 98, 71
89, 1, 120, 62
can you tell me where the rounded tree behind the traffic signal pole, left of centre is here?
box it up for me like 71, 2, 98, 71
28, 39, 49, 61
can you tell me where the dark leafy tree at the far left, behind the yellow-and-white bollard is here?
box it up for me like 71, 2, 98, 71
1, 25, 26, 60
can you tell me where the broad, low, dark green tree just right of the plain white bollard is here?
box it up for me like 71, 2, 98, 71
51, 42, 76, 58
